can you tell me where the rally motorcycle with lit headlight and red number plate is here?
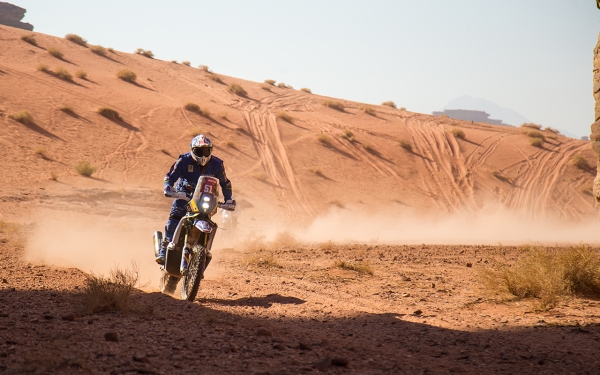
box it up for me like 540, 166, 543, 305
154, 176, 235, 301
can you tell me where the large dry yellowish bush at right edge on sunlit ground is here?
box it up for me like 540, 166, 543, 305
480, 245, 600, 309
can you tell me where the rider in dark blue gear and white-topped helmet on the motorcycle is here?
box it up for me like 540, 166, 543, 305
156, 134, 235, 265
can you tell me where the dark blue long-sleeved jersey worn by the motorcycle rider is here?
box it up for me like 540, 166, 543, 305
165, 152, 232, 200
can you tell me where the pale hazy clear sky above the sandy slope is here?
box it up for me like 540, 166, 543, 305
14, 0, 600, 136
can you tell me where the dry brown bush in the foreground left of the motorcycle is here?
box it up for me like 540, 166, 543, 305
80, 263, 139, 314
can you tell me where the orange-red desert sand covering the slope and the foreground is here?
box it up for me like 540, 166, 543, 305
0, 26, 600, 374
